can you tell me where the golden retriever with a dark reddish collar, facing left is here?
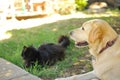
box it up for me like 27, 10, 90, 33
70, 19, 120, 80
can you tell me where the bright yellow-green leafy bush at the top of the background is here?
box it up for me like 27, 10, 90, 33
75, 0, 87, 11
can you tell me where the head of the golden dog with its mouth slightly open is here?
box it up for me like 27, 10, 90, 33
70, 19, 117, 47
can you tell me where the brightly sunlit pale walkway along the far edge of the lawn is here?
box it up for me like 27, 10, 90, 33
0, 13, 86, 41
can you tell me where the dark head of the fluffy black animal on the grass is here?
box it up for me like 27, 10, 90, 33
21, 46, 38, 67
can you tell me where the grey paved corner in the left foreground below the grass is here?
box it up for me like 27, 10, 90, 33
0, 58, 41, 80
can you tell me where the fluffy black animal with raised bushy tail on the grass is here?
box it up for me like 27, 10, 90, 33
21, 35, 70, 67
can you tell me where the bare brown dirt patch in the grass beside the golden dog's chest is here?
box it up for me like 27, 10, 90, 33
63, 51, 92, 77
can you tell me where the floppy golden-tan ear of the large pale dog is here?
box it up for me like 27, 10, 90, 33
88, 24, 103, 43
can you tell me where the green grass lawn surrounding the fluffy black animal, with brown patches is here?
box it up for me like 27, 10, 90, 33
0, 10, 120, 80
